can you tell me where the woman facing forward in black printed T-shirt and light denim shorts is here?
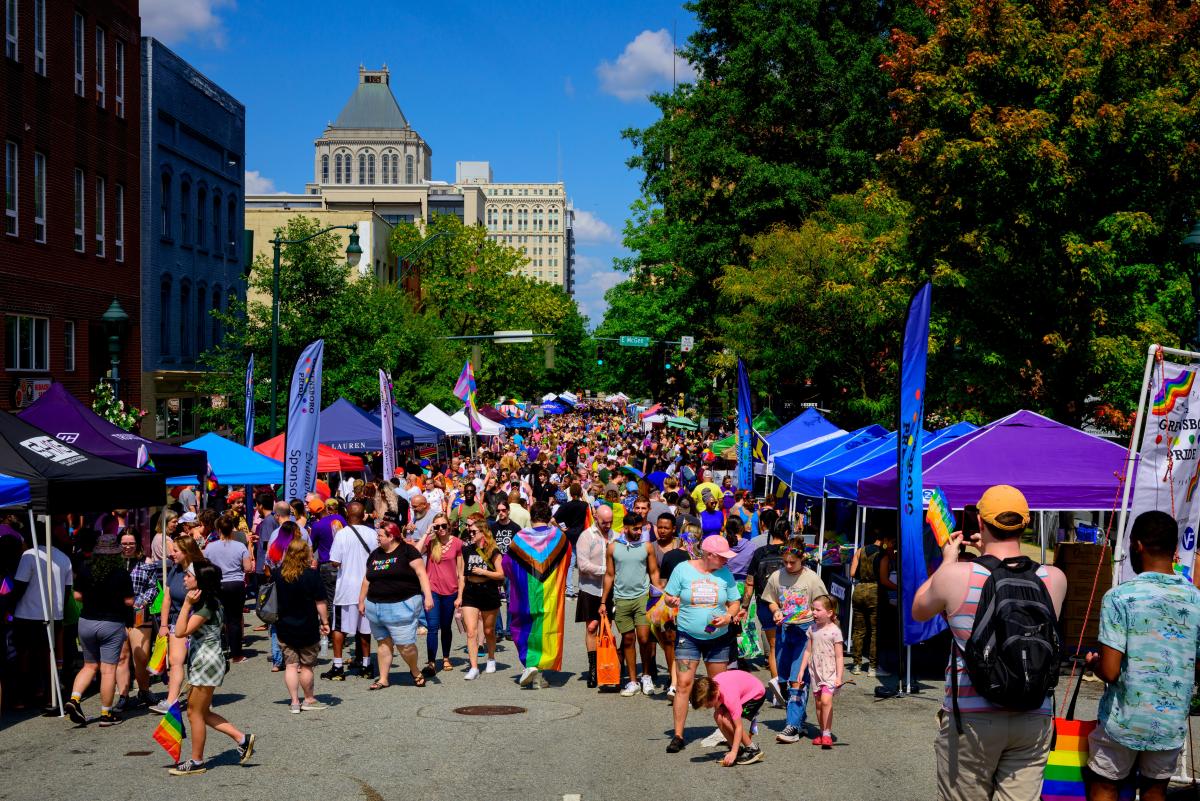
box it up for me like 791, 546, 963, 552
359, 523, 433, 689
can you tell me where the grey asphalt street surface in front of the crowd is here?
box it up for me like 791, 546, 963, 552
0, 603, 1099, 801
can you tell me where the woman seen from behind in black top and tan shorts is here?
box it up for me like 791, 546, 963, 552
275, 537, 329, 715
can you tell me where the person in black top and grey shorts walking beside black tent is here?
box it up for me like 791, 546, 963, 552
66, 534, 133, 728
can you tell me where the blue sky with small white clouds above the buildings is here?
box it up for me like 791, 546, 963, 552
140, 0, 695, 325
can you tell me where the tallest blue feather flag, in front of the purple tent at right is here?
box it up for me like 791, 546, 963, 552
896, 282, 946, 645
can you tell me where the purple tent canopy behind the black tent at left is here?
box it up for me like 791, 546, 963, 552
17, 383, 208, 476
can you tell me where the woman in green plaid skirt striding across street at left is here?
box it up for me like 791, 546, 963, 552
169, 560, 254, 776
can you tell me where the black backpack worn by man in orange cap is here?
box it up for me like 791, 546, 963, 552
950, 556, 1062, 734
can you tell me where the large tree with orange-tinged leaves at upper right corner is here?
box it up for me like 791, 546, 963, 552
884, 0, 1200, 426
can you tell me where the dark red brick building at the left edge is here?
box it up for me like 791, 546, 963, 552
0, 0, 142, 409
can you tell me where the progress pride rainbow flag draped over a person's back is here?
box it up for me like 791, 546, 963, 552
503, 525, 571, 670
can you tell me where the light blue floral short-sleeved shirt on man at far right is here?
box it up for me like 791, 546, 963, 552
1099, 573, 1200, 751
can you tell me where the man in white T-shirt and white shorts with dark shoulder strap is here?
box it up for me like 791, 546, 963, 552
320, 501, 378, 681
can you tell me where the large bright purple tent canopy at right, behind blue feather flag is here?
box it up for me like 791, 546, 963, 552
858, 410, 1126, 511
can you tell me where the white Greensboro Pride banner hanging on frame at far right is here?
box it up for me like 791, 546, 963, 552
1121, 359, 1200, 582
